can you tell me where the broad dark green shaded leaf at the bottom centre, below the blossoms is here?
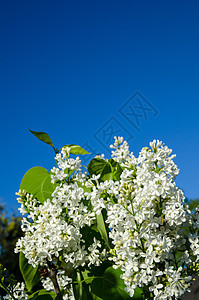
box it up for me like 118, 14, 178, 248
91, 267, 132, 300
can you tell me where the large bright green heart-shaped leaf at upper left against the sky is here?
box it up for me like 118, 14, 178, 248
20, 167, 55, 203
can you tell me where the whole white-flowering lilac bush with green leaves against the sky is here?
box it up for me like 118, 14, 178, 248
1, 132, 199, 300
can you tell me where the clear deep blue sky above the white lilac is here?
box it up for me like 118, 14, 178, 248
0, 0, 199, 211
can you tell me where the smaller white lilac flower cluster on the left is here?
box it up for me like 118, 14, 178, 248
15, 148, 105, 268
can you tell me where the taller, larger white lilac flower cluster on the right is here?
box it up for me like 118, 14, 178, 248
107, 139, 196, 300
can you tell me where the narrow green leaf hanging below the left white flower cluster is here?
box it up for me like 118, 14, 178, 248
19, 252, 41, 292
